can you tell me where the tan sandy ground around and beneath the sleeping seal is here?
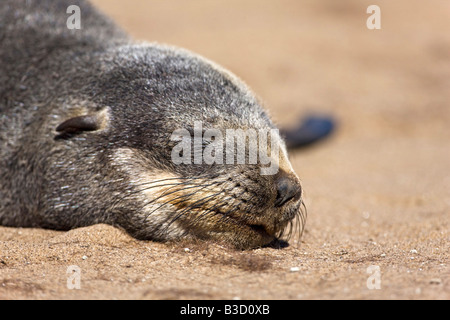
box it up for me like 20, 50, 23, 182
0, 0, 450, 299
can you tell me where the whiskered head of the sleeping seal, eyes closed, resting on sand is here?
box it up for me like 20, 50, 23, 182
66, 46, 304, 248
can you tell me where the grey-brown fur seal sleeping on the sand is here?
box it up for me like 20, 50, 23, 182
0, 0, 326, 248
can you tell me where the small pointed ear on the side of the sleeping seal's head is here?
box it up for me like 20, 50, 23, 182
56, 109, 108, 136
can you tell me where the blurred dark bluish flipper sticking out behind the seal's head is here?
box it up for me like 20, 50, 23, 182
280, 116, 336, 149
